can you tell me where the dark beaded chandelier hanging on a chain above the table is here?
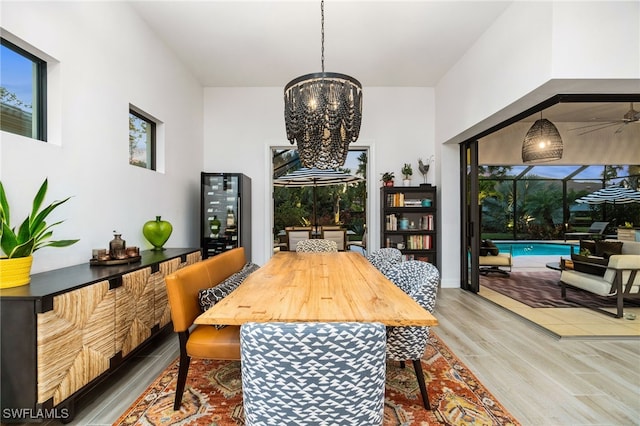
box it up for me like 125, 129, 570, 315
284, 0, 362, 169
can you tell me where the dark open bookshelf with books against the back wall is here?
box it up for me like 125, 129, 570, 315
380, 184, 438, 266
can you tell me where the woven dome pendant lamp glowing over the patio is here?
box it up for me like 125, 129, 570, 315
522, 111, 563, 163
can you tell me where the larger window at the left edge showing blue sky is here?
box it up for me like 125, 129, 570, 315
0, 38, 47, 141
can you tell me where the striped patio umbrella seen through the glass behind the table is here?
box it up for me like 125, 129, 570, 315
273, 167, 364, 229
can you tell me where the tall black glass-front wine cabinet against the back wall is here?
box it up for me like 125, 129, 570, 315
200, 172, 251, 260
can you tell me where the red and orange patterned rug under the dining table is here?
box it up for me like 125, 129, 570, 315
114, 332, 519, 426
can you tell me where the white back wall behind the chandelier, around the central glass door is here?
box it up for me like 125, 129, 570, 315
204, 87, 435, 264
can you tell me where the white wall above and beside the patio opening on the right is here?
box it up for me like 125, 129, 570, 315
435, 1, 640, 287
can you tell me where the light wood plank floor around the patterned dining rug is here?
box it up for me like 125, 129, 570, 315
22, 289, 640, 426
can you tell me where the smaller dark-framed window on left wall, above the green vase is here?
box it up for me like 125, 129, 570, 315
129, 109, 156, 170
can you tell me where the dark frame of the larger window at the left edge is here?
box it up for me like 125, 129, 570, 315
0, 37, 47, 142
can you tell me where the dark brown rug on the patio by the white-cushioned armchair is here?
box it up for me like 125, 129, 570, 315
480, 271, 637, 308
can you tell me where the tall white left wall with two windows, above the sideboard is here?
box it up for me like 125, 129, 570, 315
0, 1, 202, 273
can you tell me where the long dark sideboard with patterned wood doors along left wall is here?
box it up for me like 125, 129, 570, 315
0, 248, 202, 423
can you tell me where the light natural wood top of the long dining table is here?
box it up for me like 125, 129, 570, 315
195, 252, 438, 326
